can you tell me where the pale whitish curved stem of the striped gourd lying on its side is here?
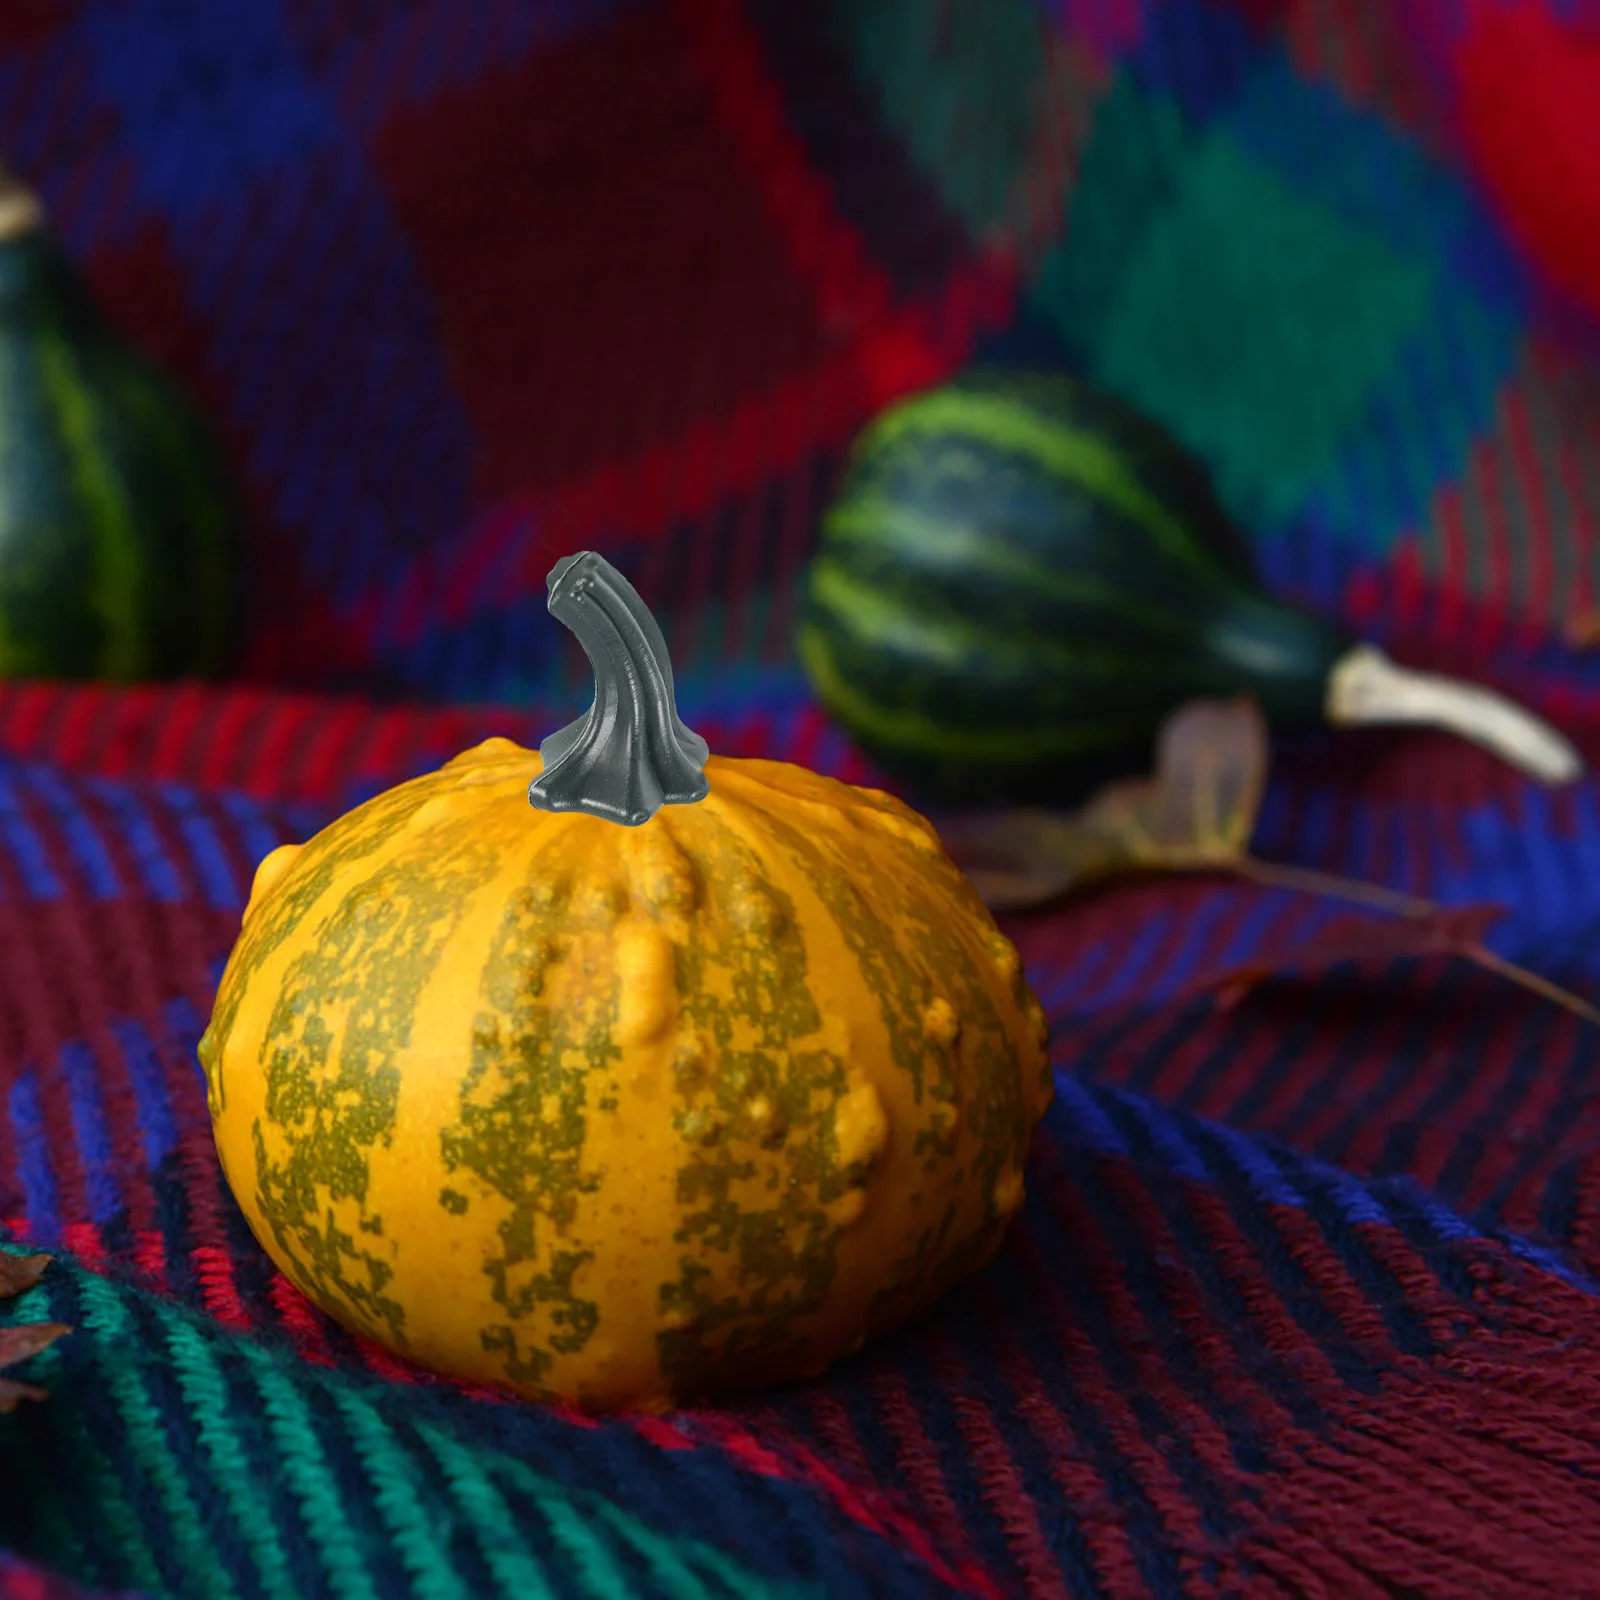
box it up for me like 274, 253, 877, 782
1326, 645, 1584, 784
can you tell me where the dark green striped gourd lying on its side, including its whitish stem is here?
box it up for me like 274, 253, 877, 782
797, 370, 1581, 798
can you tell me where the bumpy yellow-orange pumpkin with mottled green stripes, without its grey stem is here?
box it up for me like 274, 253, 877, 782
200, 739, 1051, 1411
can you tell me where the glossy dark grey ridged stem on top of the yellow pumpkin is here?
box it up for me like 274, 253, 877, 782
528, 550, 710, 827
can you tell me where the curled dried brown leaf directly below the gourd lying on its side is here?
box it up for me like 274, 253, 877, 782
939, 699, 1267, 910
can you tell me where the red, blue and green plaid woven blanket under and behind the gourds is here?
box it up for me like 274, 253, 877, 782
0, 0, 1600, 1600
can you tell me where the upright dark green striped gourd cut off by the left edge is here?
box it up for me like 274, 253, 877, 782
0, 171, 237, 682
